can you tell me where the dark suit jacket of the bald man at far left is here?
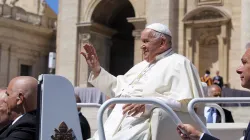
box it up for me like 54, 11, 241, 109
0, 111, 36, 140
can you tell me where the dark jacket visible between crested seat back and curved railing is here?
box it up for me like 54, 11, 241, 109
79, 113, 91, 140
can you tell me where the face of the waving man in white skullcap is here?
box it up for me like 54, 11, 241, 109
141, 29, 162, 63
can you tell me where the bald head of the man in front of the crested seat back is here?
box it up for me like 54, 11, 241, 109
7, 76, 37, 113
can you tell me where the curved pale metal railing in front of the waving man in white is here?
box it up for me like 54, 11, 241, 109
97, 98, 182, 140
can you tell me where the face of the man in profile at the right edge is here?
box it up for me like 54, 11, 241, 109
236, 49, 250, 89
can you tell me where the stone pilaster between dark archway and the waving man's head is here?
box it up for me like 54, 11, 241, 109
127, 18, 146, 65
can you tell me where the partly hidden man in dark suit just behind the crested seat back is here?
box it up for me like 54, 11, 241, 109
75, 95, 91, 140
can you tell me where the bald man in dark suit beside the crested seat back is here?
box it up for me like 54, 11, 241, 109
0, 76, 37, 140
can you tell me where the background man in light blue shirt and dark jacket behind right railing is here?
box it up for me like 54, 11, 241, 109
204, 85, 234, 123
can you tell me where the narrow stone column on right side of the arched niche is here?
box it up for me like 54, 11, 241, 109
218, 24, 229, 84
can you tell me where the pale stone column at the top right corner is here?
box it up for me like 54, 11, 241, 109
241, 0, 250, 54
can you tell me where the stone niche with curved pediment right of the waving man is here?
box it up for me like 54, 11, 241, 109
183, 6, 231, 83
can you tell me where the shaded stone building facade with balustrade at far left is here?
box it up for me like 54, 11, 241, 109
0, 0, 56, 87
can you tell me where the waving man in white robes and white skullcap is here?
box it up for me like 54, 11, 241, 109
81, 23, 203, 140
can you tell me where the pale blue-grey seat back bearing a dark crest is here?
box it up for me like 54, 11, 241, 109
38, 75, 82, 140
